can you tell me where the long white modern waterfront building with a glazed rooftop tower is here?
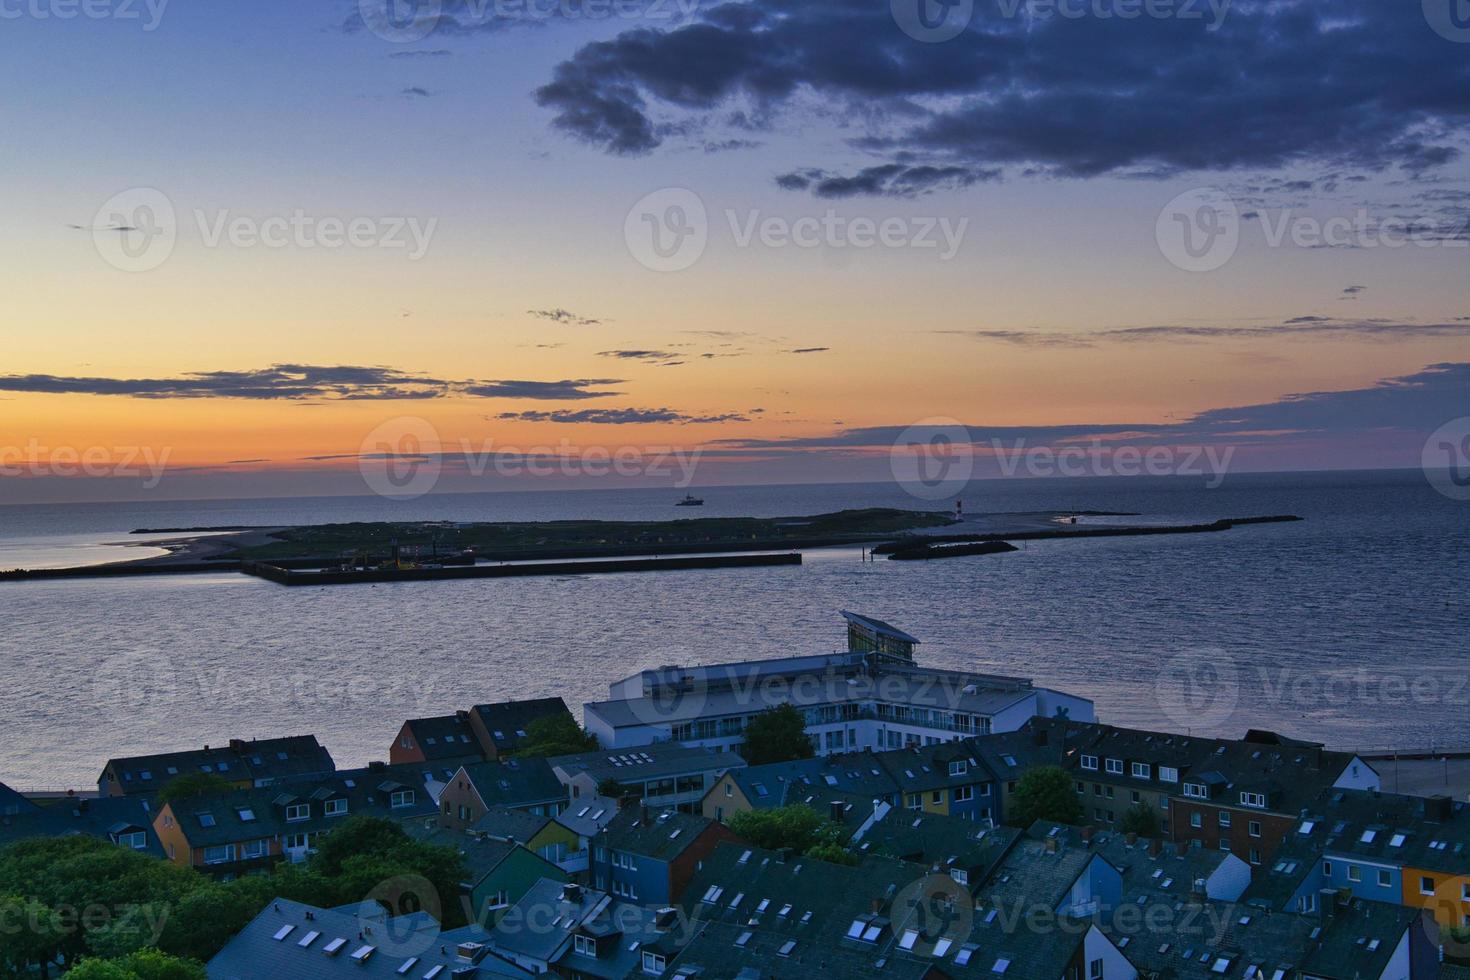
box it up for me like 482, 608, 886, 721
584, 613, 1095, 755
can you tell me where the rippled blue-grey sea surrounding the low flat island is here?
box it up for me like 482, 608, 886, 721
0, 472, 1470, 789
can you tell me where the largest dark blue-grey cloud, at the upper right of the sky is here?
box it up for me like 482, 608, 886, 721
537, 0, 1470, 197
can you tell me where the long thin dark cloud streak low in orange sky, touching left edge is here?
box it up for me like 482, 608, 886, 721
0, 364, 622, 401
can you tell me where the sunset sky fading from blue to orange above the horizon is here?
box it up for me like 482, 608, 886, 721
0, 0, 1470, 502
